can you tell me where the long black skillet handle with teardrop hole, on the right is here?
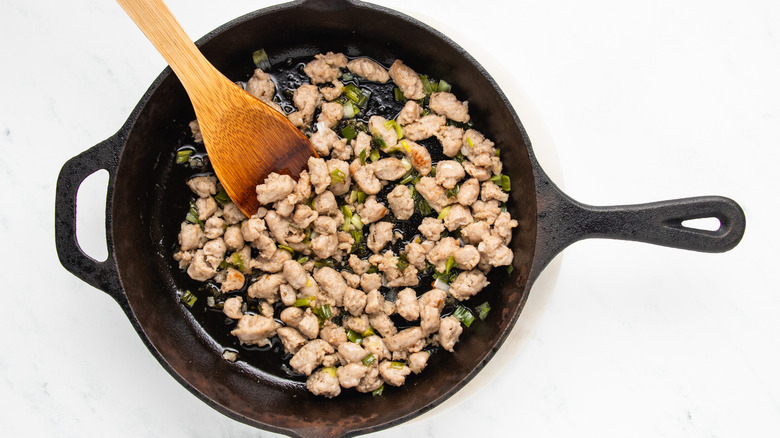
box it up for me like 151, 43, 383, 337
536, 181, 745, 280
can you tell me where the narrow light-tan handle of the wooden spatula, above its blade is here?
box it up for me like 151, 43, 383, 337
117, 0, 229, 100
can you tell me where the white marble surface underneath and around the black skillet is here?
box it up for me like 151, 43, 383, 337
0, 0, 780, 437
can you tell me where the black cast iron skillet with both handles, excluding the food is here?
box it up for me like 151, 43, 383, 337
56, 0, 745, 437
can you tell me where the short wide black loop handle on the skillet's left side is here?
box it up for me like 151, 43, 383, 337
54, 131, 124, 304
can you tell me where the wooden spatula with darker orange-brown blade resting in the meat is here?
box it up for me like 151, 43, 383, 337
117, 0, 317, 216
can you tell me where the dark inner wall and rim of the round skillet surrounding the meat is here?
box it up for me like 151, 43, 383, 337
111, 2, 536, 435
